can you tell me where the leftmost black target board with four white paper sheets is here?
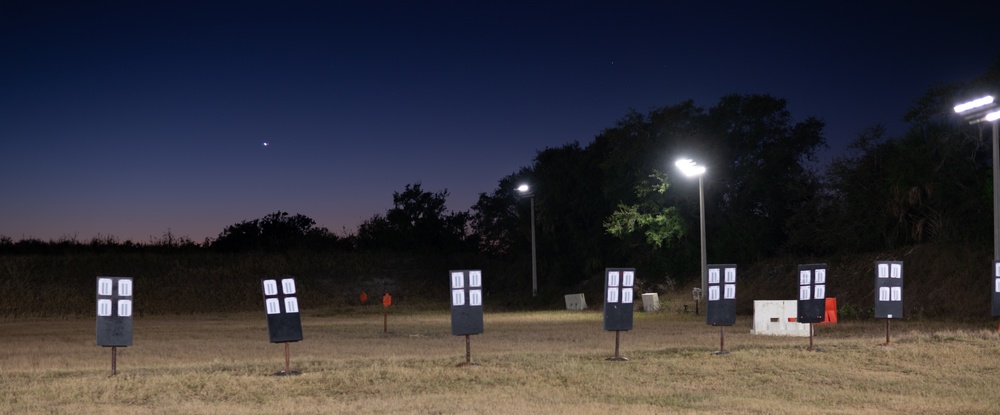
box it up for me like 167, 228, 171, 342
97, 277, 134, 347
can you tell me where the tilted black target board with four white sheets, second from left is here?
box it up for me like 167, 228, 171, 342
261, 277, 302, 343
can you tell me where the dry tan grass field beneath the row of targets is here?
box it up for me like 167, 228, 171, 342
0, 307, 1000, 414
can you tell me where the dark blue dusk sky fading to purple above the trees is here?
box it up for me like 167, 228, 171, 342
0, 0, 1000, 242
